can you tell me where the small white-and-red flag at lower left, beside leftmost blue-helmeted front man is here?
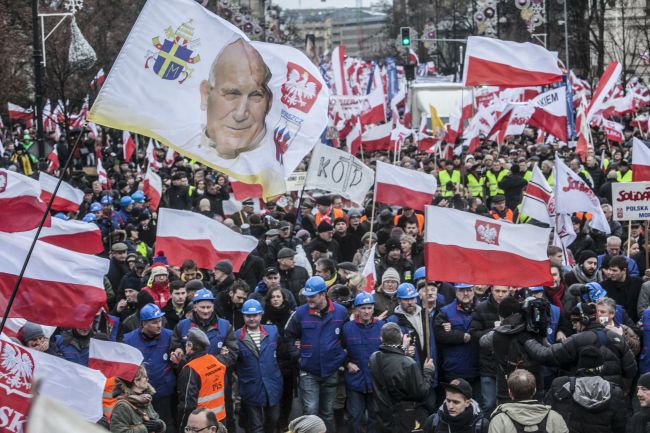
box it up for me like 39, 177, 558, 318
88, 338, 144, 382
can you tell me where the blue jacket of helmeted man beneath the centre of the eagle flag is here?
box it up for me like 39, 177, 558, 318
436, 299, 479, 380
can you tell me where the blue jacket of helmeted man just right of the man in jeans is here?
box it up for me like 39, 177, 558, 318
343, 319, 384, 393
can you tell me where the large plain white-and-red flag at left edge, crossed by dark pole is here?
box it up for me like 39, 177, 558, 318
0, 233, 109, 328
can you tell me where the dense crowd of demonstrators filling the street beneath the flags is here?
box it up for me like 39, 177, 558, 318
0, 104, 650, 433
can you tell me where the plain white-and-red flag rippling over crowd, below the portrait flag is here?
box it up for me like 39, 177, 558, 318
156, 208, 257, 272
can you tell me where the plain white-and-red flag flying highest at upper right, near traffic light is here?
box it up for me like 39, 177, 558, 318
463, 36, 562, 87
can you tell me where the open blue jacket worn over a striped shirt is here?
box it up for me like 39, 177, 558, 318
235, 325, 282, 406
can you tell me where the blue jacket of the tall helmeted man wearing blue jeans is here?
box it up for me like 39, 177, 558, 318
284, 299, 349, 378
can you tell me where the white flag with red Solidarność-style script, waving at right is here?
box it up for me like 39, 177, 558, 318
555, 156, 611, 233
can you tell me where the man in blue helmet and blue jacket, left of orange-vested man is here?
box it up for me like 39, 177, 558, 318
123, 304, 176, 433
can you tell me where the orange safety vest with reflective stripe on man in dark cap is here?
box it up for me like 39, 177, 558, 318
183, 354, 226, 421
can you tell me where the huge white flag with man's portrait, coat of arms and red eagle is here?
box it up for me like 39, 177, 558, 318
88, 0, 329, 197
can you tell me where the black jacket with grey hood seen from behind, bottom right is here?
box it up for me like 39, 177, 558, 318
544, 376, 626, 433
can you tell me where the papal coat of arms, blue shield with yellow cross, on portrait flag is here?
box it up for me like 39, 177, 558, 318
144, 20, 201, 84
